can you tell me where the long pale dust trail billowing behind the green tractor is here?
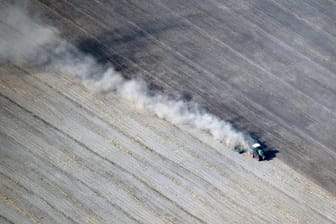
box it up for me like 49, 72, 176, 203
0, 3, 252, 149
